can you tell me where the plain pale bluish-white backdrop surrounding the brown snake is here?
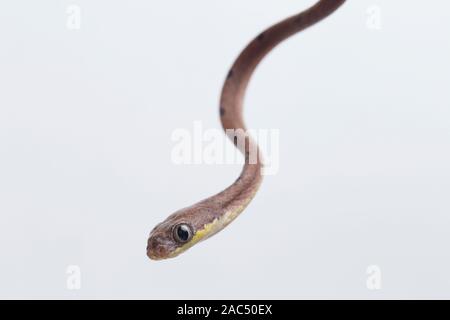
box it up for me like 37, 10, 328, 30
0, 0, 450, 299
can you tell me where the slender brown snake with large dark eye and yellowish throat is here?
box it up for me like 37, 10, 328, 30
147, 0, 346, 260
